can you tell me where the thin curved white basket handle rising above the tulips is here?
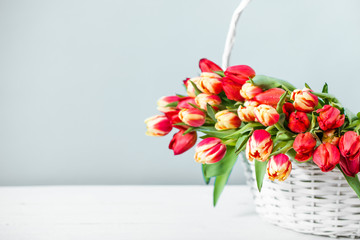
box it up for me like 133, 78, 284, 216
222, 0, 251, 70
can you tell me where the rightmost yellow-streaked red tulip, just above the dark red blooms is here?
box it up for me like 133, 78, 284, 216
291, 88, 319, 113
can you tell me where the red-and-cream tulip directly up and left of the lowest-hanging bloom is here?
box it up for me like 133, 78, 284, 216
245, 129, 273, 161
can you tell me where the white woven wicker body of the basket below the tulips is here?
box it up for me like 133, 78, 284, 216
242, 156, 360, 238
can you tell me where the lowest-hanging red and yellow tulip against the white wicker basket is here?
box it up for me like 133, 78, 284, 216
267, 153, 292, 181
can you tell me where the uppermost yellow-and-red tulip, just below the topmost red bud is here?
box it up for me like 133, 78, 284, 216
196, 72, 223, 94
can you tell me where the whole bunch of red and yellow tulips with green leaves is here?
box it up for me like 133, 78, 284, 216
145, 59, 360, 205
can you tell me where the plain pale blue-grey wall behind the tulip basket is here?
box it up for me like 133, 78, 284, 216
0, 0, 360, 185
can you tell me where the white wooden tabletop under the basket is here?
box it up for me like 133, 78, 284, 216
0, 186, 326, 240
